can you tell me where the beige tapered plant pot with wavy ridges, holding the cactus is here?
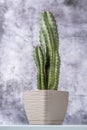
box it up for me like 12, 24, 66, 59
24, 90, 69, 125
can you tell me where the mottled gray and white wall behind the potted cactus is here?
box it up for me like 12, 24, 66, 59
0, 0, 87, 125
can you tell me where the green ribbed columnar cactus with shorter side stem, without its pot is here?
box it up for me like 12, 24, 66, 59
34, 11, 60, 90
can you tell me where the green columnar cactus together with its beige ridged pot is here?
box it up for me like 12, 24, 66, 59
24, 11, 68, 125
